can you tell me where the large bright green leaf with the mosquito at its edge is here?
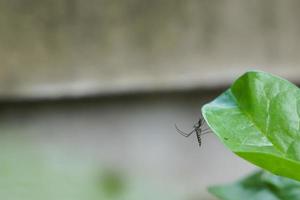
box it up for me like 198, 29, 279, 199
202, 71, 300, 180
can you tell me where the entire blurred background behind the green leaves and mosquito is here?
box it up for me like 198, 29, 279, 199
0, 0, 300, 200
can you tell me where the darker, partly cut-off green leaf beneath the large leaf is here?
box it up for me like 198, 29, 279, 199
208, 171, 300, 200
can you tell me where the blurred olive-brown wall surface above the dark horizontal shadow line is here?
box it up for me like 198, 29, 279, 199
0, 0, 300, 97
